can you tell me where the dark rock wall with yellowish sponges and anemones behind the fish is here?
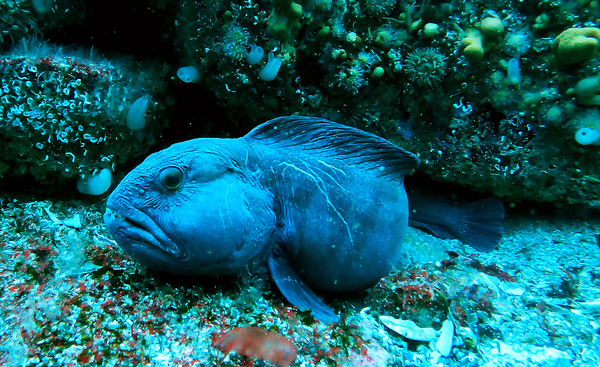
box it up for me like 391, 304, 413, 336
0, 0, 600, 206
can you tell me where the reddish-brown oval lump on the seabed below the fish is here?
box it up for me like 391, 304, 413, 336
212, 326, 297, 367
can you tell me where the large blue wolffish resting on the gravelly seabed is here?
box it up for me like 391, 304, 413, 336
104, 116, 502, 322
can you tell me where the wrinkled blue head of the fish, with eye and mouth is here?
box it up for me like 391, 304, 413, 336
104, 139, 276, 275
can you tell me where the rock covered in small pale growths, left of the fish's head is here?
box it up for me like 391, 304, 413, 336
0, 39, 168, 185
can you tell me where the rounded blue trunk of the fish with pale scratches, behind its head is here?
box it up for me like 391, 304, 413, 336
251, 131, 418, 292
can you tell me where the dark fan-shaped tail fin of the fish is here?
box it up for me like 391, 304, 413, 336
455, 197, 504, 252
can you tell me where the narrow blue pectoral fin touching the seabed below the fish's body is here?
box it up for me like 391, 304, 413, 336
268, 247, 340, 324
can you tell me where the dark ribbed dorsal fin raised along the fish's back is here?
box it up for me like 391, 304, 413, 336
244, 116, 419, 180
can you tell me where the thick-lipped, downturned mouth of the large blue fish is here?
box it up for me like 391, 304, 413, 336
104, 207, 188, 259
